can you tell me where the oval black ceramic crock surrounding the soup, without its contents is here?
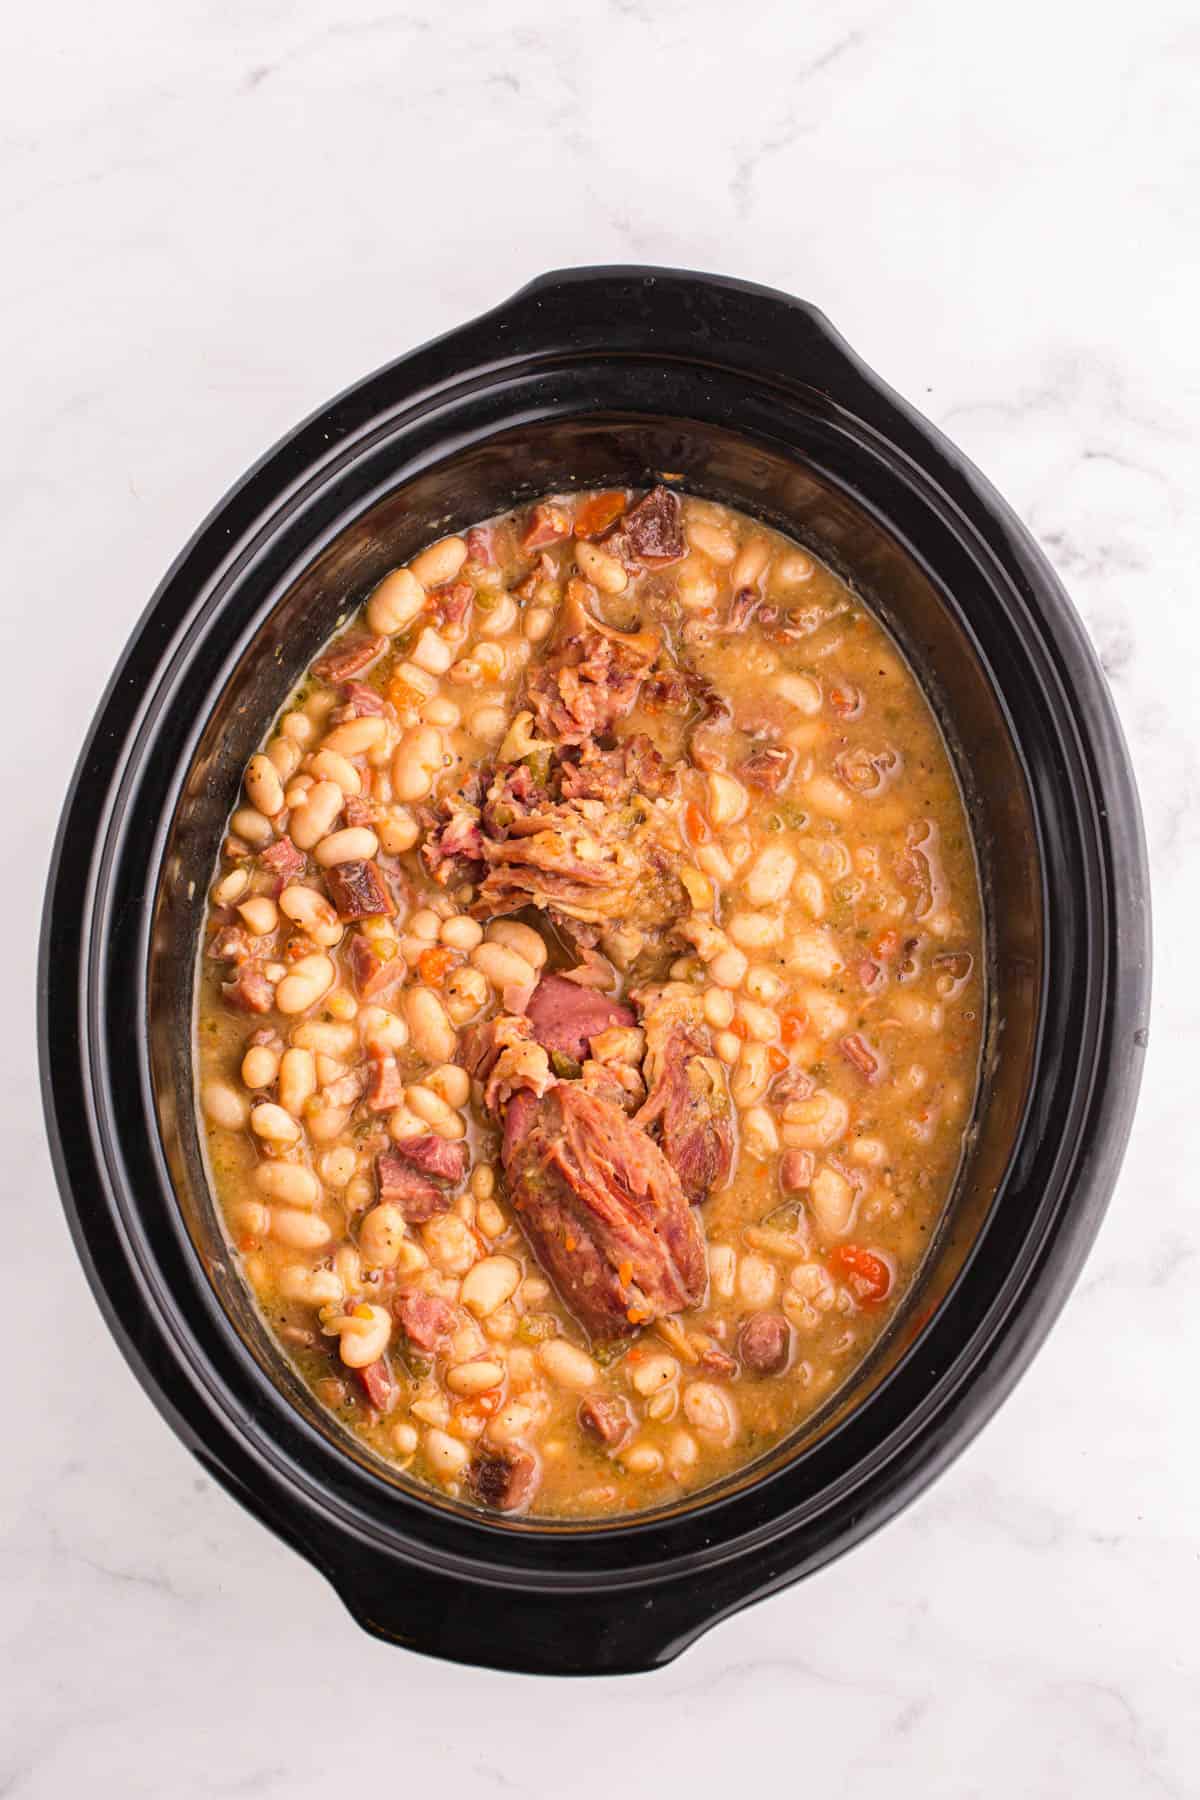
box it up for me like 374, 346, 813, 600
40, 268, 1150, 1674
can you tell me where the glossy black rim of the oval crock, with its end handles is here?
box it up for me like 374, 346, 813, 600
38, 268, 1150, 1672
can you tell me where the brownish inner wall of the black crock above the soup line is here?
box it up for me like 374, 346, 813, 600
149, 416, 1042, 1505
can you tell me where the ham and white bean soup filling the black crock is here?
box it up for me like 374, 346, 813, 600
198, 486, 984, 1517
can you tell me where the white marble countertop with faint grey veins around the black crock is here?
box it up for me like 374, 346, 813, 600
0, 0, 1200, 1800
